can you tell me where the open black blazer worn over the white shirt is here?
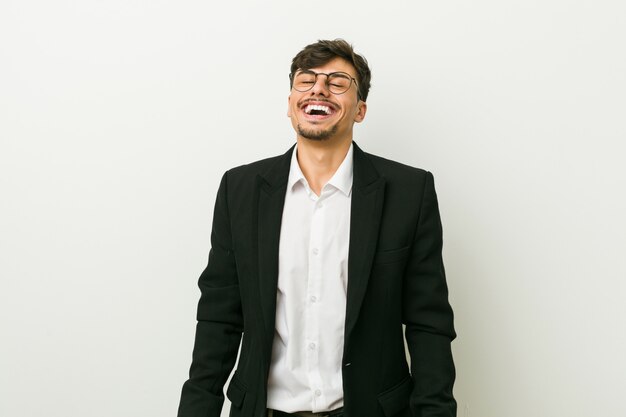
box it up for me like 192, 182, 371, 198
178, 143, 456, 417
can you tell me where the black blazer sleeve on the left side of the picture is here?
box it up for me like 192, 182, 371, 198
178, 173, 243, 417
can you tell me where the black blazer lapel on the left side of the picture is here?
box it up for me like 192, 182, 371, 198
253, 146, 294, 350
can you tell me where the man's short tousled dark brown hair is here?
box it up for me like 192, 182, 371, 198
290, 39, 372, 101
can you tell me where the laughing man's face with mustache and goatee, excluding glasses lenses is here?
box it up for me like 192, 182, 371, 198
287, 58, 367, 141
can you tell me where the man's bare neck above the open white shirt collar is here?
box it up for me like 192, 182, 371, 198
297, 137, 352, 196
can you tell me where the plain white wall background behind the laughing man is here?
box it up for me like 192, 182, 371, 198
0, 0, 626, 417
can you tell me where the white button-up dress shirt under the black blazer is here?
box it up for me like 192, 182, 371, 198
267, 141, 353, 412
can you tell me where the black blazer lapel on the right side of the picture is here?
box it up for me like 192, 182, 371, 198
344, 143, 385, 349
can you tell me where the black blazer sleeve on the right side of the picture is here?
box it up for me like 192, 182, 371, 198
402, 172, 456, 417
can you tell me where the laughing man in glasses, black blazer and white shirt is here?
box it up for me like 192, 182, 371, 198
178, 39, 456, 417
